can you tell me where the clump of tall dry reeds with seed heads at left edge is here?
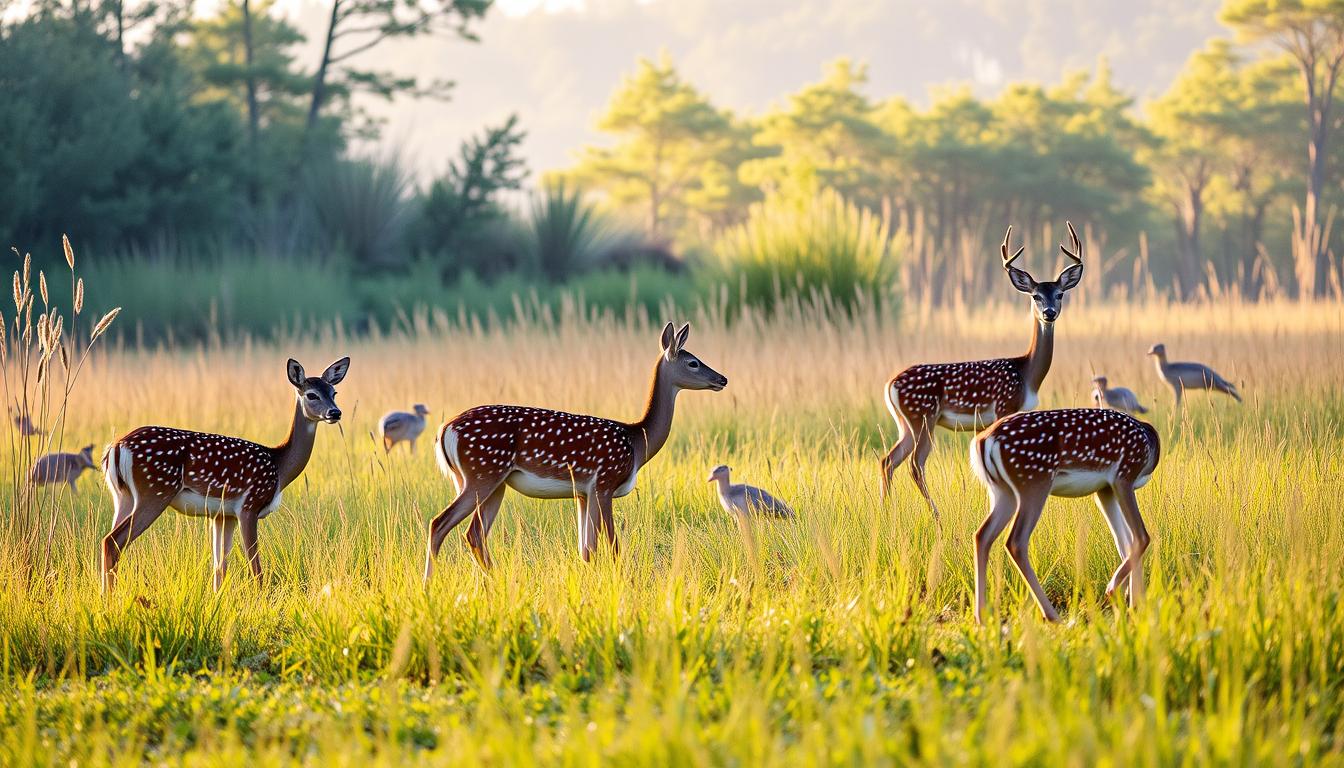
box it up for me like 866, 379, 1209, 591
0, 235, 121, 576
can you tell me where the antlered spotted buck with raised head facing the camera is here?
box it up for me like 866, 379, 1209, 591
882, 223, 1083, 516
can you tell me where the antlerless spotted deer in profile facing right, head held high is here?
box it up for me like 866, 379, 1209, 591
425, 323, 728, 581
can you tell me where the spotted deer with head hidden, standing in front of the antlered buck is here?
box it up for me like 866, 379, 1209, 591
970, 408, 1161, 621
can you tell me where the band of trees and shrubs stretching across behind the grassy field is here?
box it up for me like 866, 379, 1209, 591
0, 0, 1344, 316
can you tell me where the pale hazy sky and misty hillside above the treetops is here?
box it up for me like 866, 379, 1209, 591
272, 0, 1227, 178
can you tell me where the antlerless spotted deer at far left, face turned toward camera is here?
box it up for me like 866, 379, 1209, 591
102, 358, 349, 590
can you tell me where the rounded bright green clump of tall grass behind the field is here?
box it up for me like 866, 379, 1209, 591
711, 190, 896, 309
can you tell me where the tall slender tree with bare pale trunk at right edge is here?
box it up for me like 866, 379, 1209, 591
1222, 0, 1344, 296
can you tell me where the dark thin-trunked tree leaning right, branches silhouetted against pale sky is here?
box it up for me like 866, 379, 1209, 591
300, 0, 492, 159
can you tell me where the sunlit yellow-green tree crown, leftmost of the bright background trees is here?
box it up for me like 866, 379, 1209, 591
567, 55, 745, 239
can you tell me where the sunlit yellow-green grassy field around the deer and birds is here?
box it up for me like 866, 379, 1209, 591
0, 303, 1344, 765
